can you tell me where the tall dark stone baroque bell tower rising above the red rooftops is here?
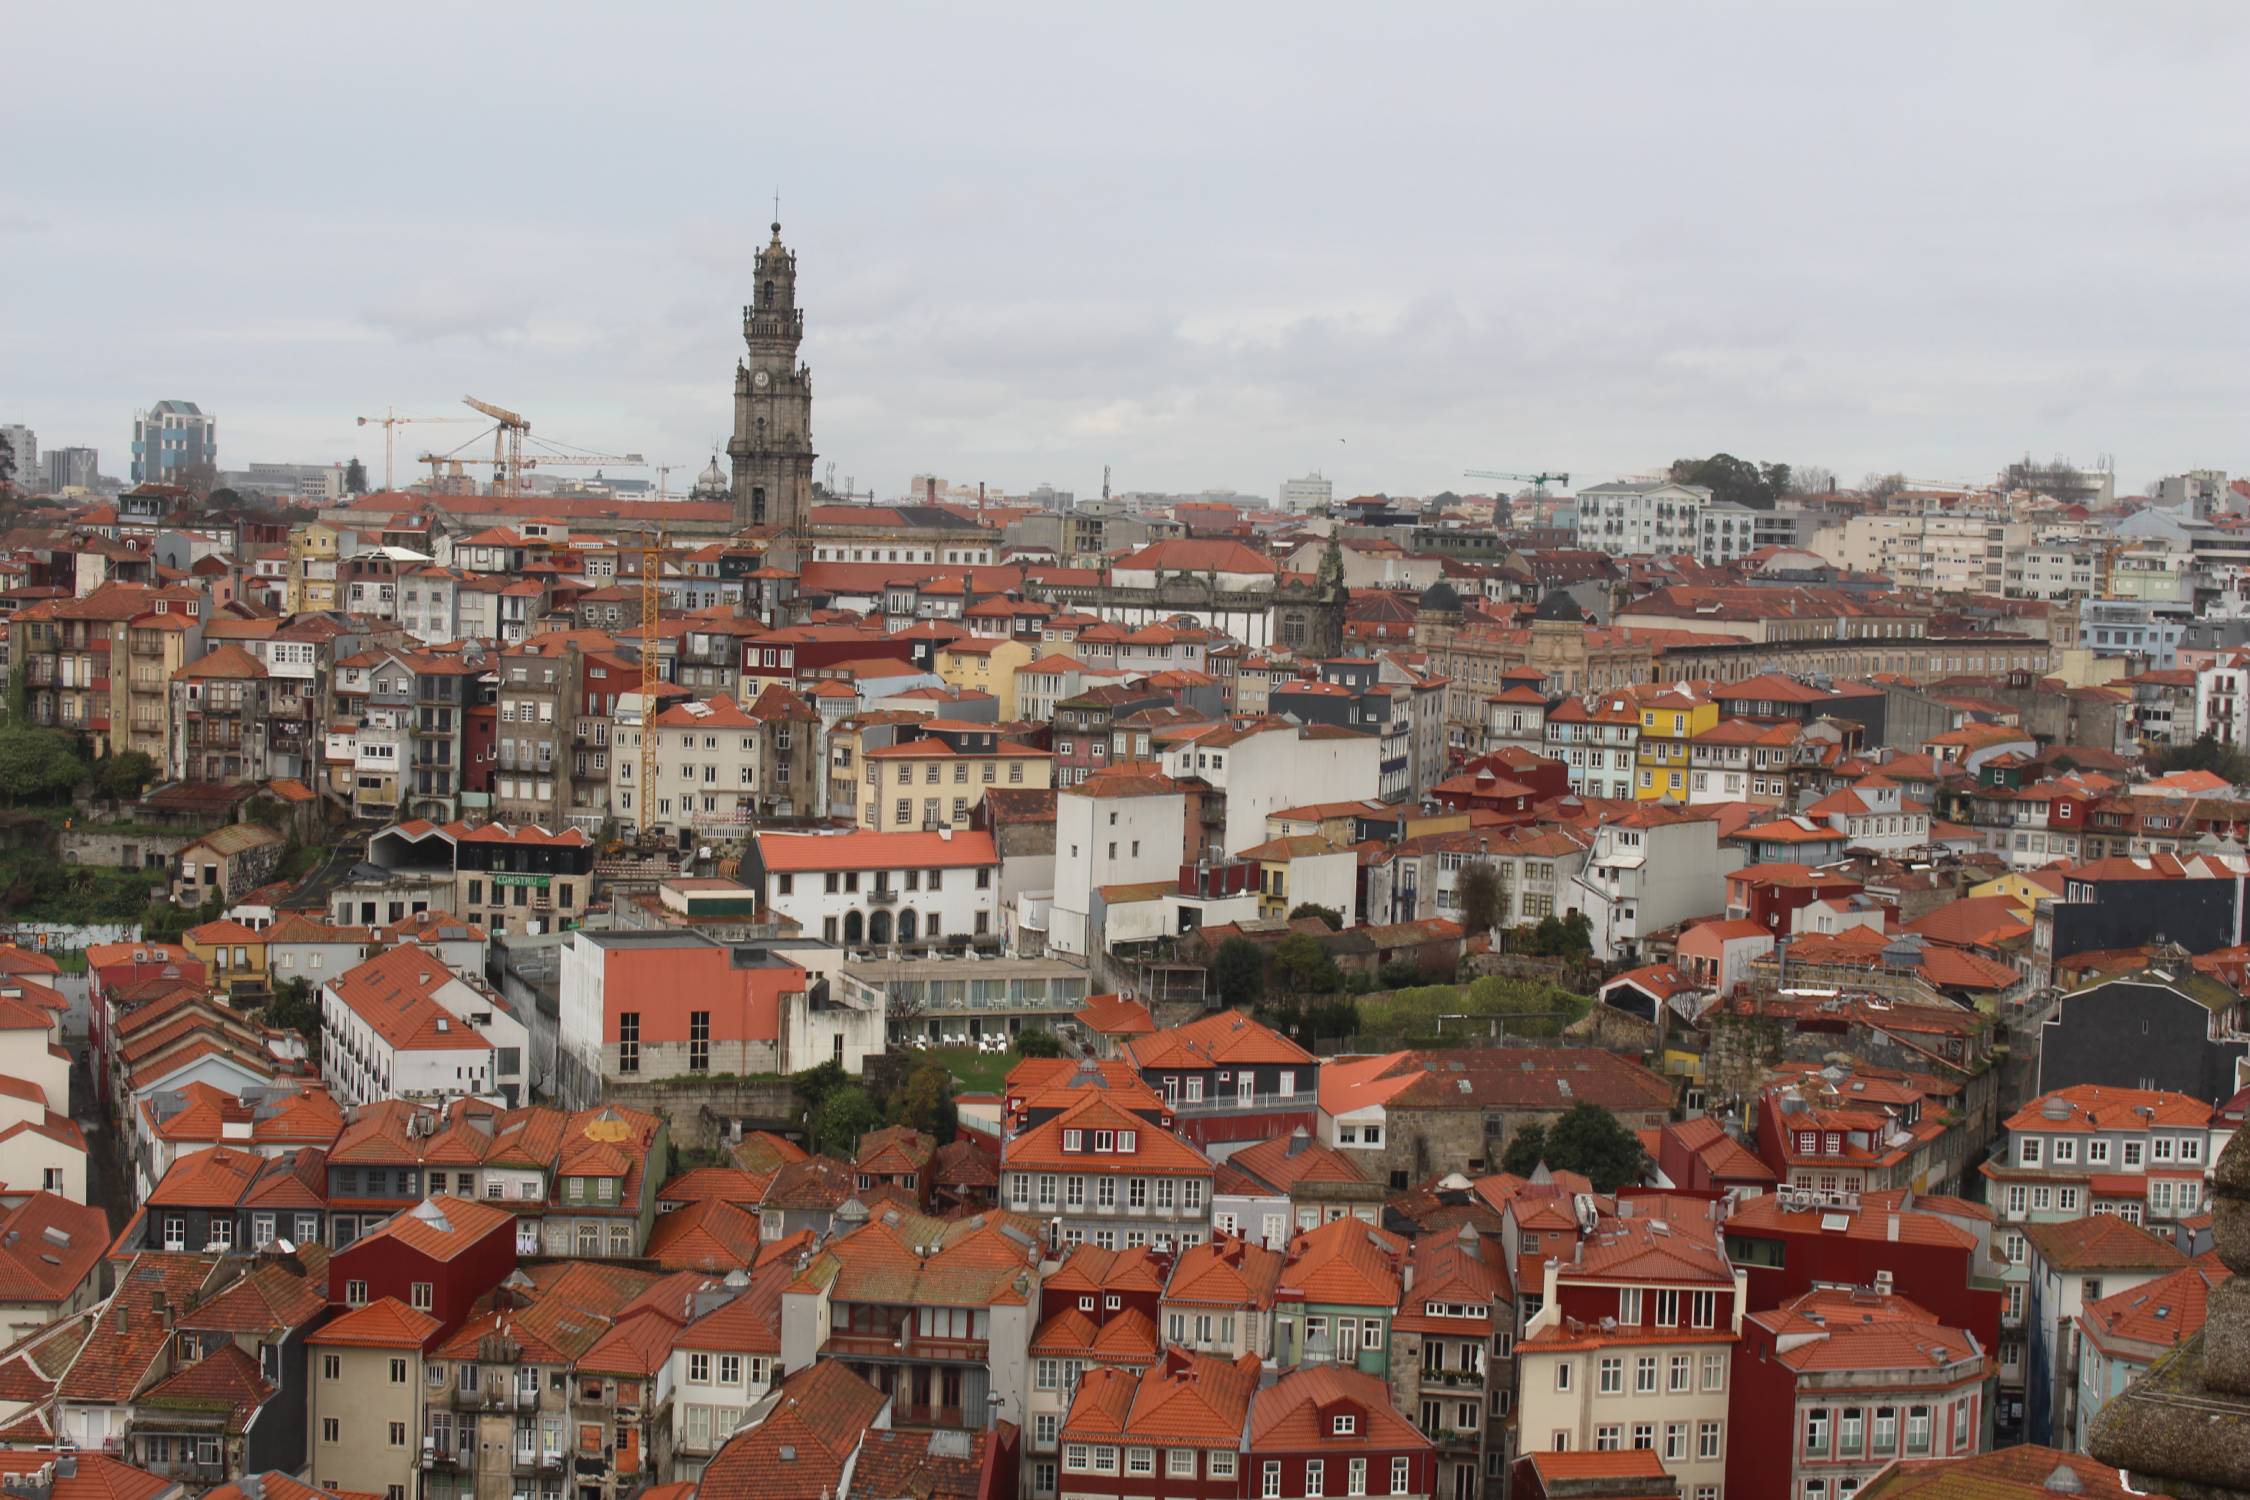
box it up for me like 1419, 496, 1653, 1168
727, 223, 815, 531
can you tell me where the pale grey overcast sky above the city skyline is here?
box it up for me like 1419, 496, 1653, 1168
0, 0, 2250, 497
